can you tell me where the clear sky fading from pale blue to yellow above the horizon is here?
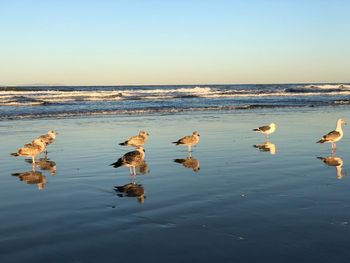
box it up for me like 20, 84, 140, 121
0, 0, 350, 85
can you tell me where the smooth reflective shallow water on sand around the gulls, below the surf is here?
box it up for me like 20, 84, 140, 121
0, 107, 350, 263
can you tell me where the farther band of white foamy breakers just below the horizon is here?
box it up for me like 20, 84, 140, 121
0, 84, 350, 106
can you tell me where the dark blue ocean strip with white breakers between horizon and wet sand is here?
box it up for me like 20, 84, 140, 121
0, 83, 350, 120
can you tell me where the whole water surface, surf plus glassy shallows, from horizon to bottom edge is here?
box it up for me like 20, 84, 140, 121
0, 83, 350, 263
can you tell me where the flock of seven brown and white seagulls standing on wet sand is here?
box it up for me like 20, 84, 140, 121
11, 119, 346, 179
